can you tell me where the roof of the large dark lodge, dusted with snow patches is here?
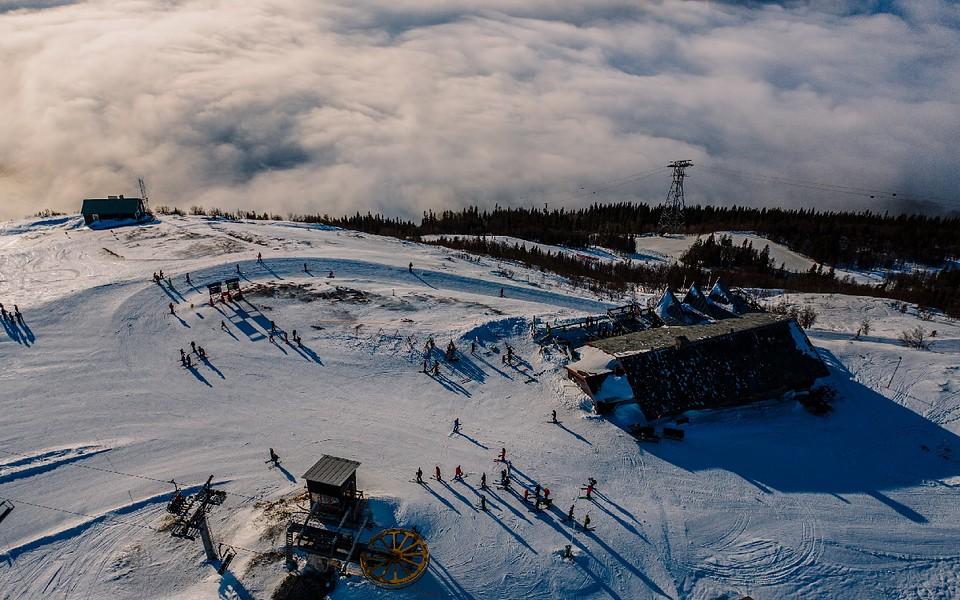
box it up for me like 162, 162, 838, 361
589, 313, 827, 420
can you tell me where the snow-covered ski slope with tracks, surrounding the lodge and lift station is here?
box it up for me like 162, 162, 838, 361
0, 217, 960, 599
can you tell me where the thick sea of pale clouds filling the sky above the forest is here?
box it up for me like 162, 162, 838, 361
0, 0, 960, 218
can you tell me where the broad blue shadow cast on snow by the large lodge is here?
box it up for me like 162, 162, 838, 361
646, 348, 960, 522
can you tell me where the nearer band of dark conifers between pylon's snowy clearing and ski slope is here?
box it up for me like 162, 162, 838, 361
430, 236, 960, 317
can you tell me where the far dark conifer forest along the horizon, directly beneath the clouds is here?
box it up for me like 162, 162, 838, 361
292, 202, 960, 269
